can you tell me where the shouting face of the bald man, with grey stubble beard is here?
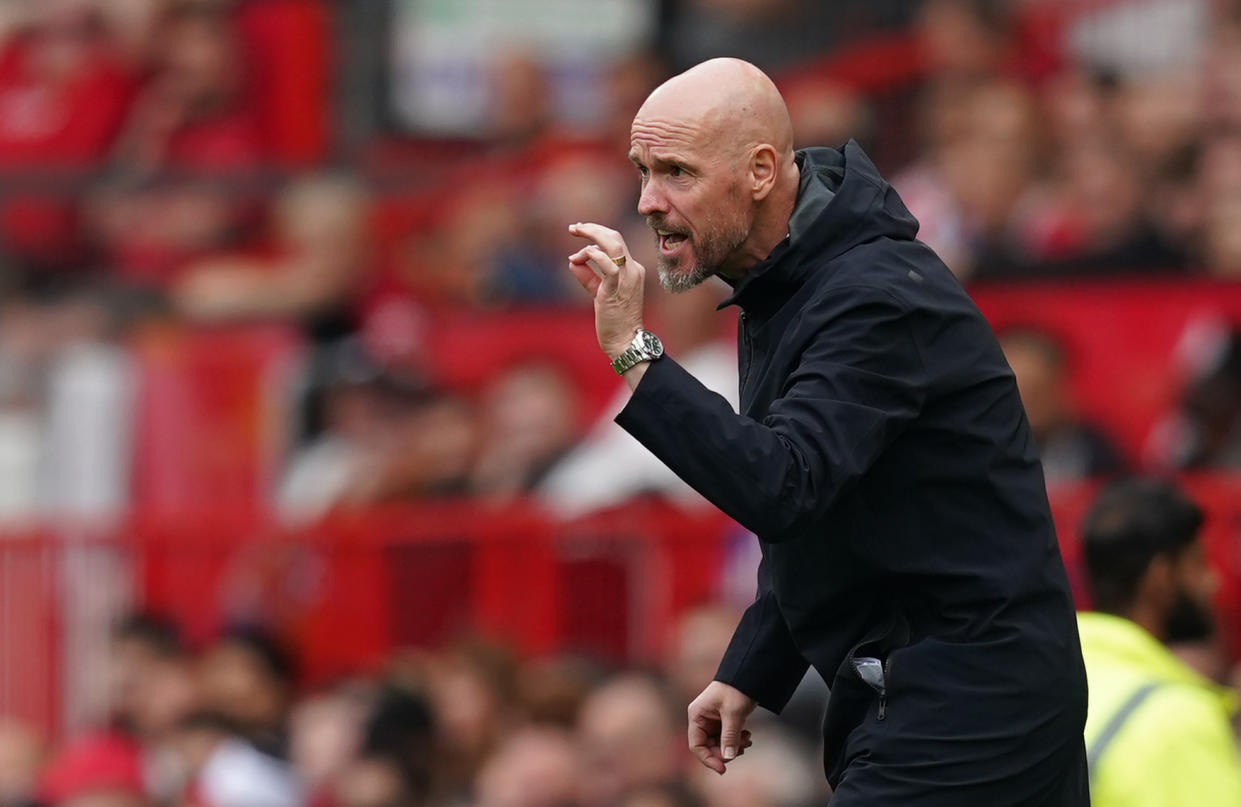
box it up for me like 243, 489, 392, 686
629, 114, 751, 292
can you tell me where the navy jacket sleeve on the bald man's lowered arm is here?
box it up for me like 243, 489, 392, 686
715, 553, 809, 713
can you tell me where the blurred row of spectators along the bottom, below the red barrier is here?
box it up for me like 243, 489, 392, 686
0, 606, 827, 807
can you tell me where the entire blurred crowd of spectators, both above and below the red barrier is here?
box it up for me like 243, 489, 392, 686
0, 0, 1241, 807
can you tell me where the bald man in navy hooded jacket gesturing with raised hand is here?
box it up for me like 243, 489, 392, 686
568, 60, 1088, 807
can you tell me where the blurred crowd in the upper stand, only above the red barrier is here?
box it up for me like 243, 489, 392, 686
0, 0, 1241, 519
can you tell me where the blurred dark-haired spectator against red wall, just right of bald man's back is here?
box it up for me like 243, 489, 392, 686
999, 328, 1124, 484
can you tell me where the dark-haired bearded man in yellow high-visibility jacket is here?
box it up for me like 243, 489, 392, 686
1080, 479, 1241, 807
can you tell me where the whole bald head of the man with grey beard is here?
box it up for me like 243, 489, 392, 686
629, 58, 798, 291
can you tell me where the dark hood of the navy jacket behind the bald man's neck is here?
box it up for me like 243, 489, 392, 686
720, 140, 918, 308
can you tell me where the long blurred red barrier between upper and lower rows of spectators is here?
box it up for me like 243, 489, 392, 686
7, 476, 1241, 729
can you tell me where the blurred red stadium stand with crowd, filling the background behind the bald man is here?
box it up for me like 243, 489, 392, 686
0, 0, 1241, 807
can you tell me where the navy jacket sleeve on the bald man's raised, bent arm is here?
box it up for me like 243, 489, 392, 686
616, 289, 927, 541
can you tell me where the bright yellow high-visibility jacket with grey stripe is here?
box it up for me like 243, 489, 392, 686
1078, 613, 1241, 807
